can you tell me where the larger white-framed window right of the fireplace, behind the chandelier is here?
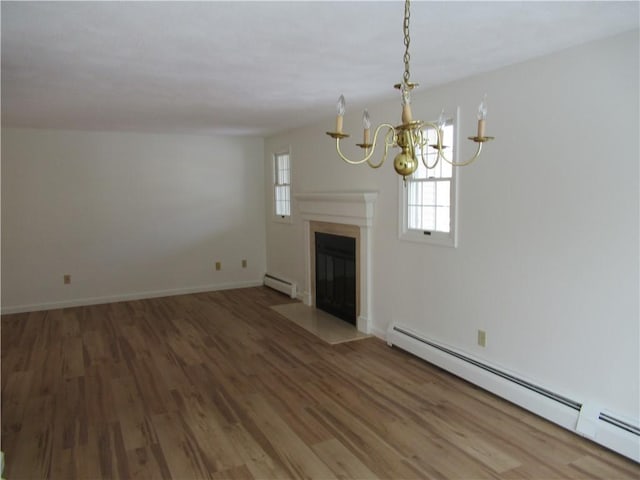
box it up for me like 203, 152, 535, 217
400, 113, 458, 247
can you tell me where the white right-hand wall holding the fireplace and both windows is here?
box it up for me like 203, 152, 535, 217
265, 31, 640, 422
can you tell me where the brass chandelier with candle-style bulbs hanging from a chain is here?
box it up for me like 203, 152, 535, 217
326, 0, 494, 180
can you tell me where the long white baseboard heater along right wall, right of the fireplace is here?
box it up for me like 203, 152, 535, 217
387, 324, 640, 462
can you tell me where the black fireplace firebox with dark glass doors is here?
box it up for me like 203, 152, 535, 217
316, 232, 356, 325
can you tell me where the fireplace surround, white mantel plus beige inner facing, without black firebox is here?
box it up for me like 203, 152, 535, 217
295, 192, 377, 333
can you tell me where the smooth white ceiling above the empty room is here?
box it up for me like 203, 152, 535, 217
1, 0, 639, 135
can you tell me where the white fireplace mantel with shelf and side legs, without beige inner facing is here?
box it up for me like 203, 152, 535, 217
294, 192, 378, 333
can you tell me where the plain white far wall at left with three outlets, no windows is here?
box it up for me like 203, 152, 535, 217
2, 128, 266, 312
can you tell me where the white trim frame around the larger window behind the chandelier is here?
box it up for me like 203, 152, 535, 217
398, 108, 460, 248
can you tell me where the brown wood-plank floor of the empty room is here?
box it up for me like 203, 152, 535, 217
2, 288, 640, 480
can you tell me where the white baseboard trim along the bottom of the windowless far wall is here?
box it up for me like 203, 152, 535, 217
2, 280, 262, 315
